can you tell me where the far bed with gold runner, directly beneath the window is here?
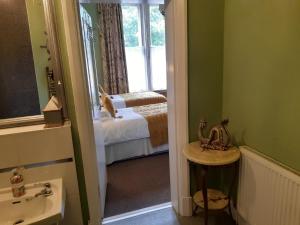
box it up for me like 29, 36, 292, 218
101, 91, 167, 109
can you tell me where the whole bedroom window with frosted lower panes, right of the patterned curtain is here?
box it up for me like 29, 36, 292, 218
122, 4, 166, 92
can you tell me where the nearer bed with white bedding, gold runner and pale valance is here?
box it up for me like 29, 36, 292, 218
94, 103, 169, 164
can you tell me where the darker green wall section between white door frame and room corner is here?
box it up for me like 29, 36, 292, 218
188, 0, 224, 141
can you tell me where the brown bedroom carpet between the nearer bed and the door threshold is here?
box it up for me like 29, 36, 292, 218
104, 153, 171, 217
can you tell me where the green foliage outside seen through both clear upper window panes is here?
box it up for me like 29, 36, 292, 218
122, 5, 165, 47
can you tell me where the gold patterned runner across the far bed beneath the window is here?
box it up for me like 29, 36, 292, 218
120, 91, 167, 107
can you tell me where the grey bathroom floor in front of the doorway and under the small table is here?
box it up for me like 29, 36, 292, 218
108, 208, 235, 225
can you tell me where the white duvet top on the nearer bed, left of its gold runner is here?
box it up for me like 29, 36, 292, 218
99, 108, 150, 145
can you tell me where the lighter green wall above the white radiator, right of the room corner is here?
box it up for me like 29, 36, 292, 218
223, 0, 300, 171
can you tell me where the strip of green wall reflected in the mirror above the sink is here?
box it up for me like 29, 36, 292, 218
25, 0, 51, 110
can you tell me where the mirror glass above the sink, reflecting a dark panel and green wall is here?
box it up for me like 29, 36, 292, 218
0, 0, 55, 119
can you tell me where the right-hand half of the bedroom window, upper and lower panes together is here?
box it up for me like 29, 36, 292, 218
150, 5, 167, 90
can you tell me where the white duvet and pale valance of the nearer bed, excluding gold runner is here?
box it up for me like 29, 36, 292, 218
94, 108, 169, 164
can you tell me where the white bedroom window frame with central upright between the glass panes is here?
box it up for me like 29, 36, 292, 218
121, 2, 166, 91
